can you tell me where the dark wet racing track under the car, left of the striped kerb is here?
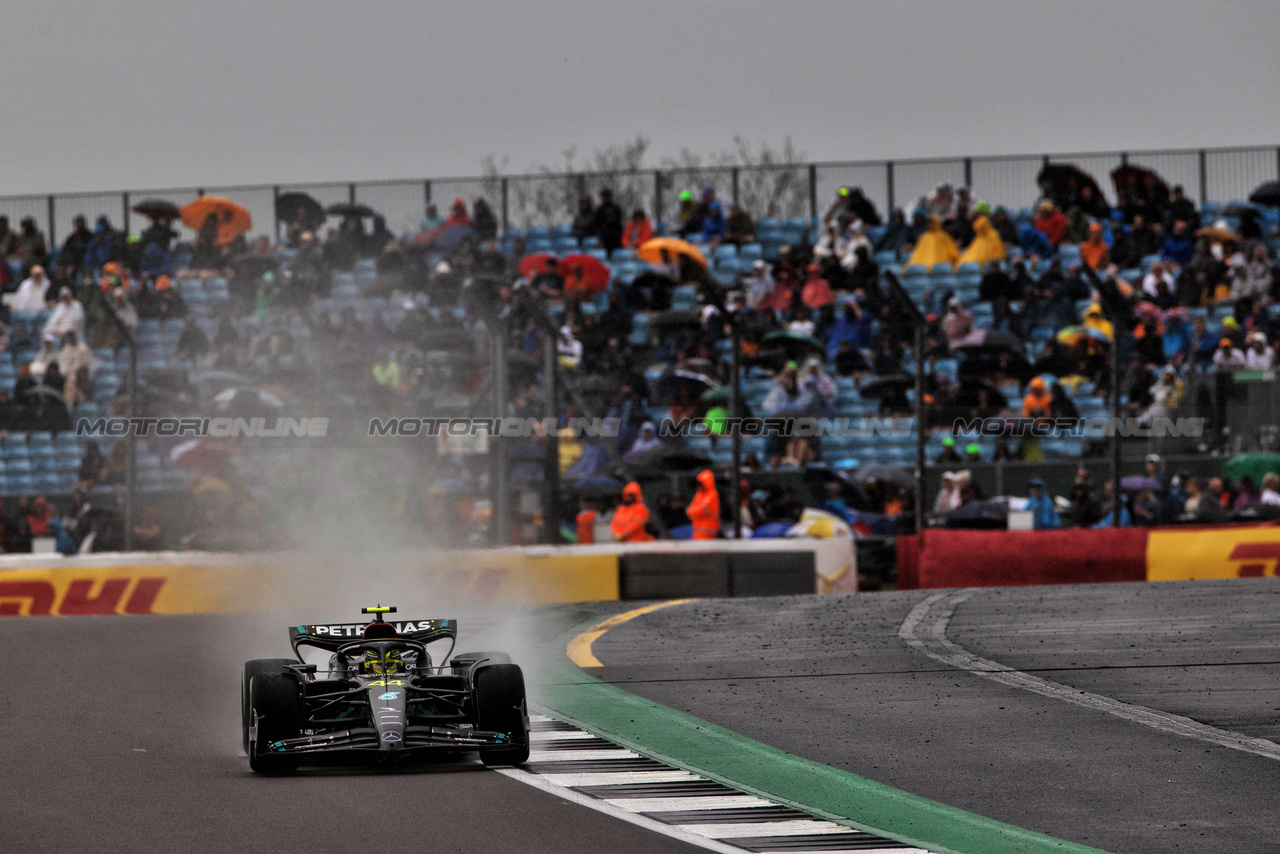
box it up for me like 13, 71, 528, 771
0, 616, 698, 854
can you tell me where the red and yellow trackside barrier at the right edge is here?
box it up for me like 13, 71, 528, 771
896, 525, 1280, 590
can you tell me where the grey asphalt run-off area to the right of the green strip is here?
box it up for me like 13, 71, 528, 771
594, 579, 1280, 854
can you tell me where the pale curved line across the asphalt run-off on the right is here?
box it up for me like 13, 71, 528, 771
897, 589, 1280, 759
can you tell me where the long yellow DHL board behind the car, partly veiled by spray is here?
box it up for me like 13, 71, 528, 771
0, 549, 620, 617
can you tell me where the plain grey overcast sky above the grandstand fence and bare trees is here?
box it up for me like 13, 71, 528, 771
0, 0, 1280, 195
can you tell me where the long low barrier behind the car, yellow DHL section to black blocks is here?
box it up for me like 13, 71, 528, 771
0, 538, 858, 617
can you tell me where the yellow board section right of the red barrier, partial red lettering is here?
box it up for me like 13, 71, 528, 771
1147, 528, 1280, 581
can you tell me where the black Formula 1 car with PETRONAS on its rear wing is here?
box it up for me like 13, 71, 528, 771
241, 606, 529, 773
